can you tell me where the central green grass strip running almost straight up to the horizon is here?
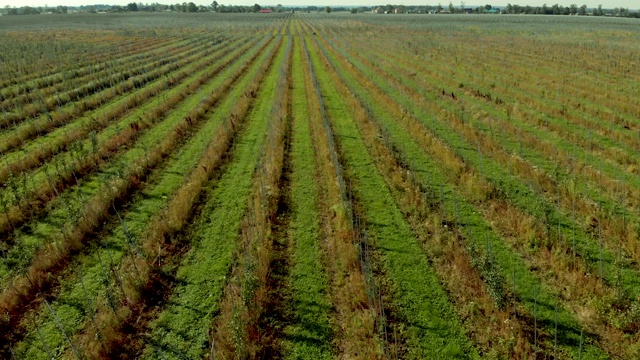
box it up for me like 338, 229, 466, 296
284, 37, 332, 359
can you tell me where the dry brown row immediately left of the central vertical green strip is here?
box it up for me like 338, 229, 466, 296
211, 35, 292, 359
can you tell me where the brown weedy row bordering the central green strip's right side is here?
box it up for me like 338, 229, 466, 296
296, 31, 386, 358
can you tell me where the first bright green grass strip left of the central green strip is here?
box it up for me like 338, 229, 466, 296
144, 38, 284, 359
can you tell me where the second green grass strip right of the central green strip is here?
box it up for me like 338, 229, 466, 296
310, 28, 598, 358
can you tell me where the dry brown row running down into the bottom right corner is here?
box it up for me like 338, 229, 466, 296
316, 28, 635, 356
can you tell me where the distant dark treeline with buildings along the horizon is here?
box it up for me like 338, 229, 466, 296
4, 1, 640, 18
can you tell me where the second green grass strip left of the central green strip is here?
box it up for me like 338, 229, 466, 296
14, 36, 274, 360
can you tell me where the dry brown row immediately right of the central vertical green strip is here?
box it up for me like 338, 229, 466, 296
303, 28, 383, 359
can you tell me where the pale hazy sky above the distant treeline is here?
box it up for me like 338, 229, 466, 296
0, 0, 640, 10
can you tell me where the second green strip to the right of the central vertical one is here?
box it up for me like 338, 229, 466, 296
318, 37, 607, 359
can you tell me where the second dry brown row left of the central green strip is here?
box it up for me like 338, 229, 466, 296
76, 35, 278, 358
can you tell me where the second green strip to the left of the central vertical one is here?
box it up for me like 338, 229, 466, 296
11, 31, 274, 359
